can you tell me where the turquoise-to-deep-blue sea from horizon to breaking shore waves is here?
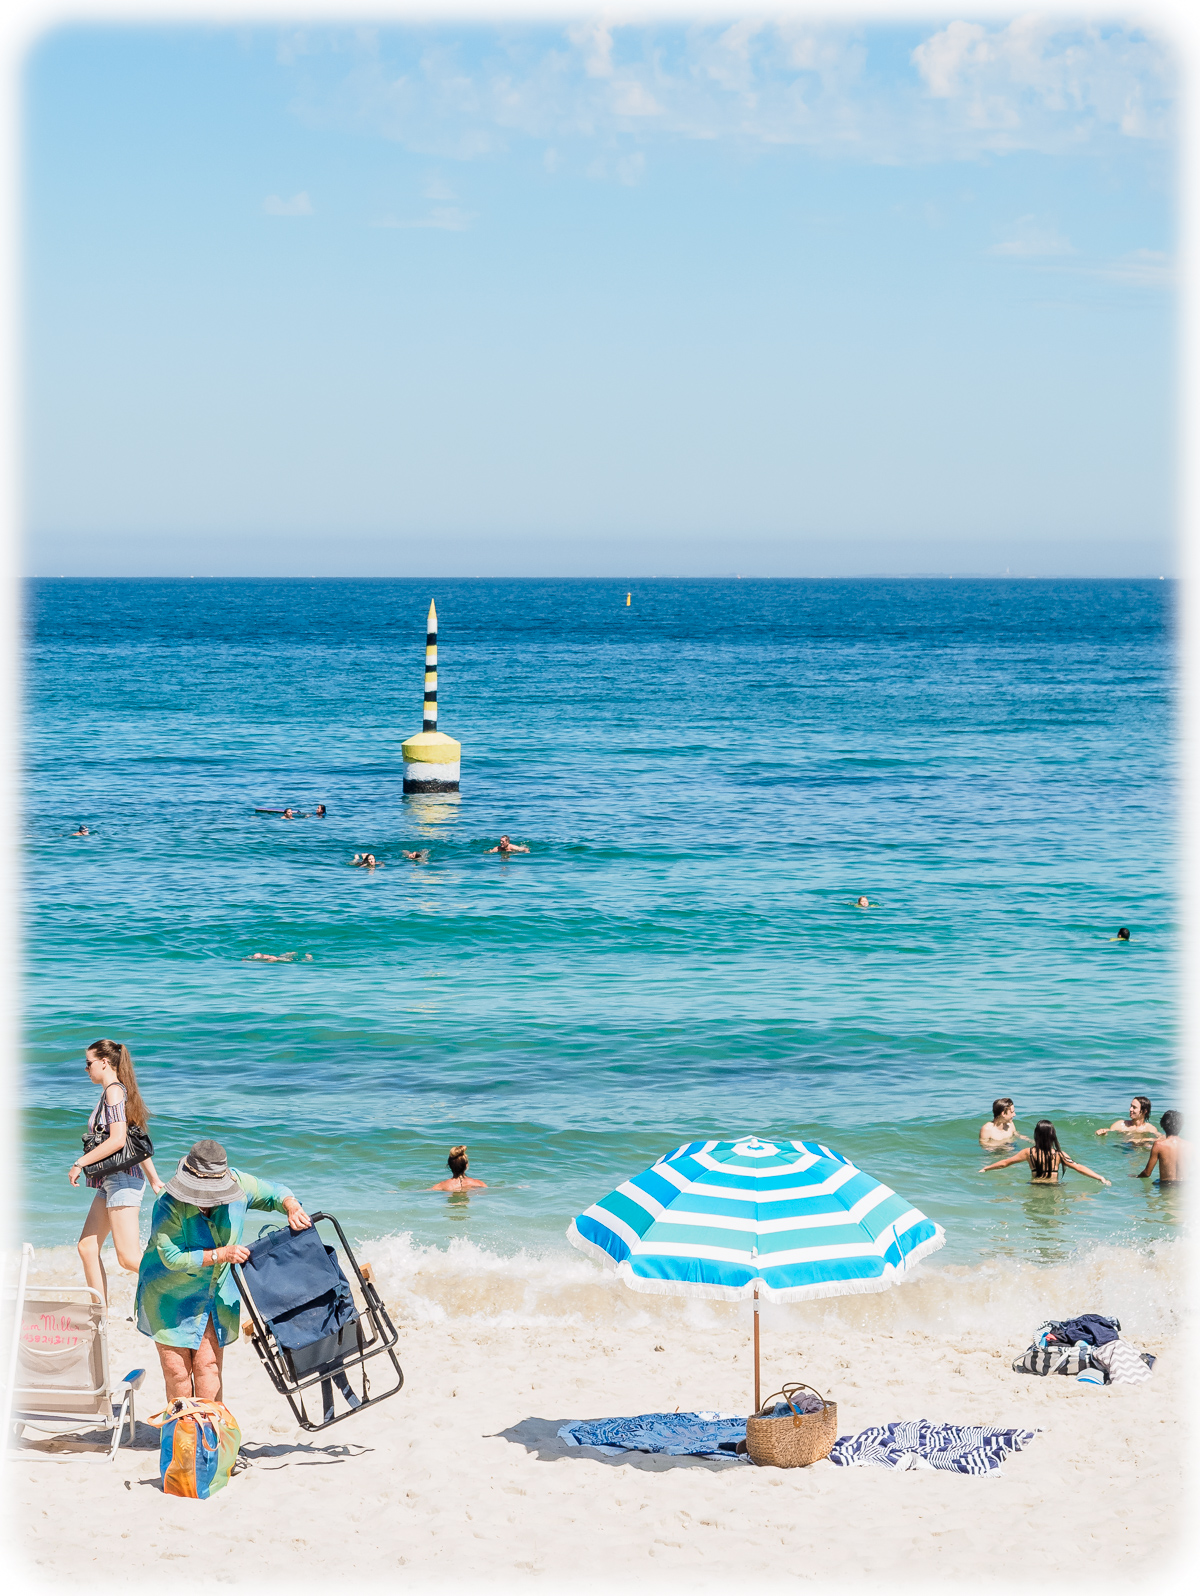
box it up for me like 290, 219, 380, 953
24, 579, 1178, 1264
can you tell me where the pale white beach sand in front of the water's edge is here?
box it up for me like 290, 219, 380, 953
8, 1248, 1184, 1591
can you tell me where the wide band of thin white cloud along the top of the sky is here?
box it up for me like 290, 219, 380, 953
282, 18, 1174, 171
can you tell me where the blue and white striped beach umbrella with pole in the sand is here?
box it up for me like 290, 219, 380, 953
566, 1136, 946, 1408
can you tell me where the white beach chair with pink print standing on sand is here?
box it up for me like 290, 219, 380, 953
5, 1248, 145, 1462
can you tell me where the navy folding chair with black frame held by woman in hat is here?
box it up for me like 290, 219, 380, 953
233, 1213, 404, 1430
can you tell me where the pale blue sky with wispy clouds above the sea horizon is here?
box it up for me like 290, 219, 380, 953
22, 18, 1178, 578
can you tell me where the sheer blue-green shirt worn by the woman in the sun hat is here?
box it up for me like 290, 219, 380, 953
137, 1170, 292, 1350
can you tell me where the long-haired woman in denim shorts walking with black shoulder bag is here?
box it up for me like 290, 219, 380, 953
67, 1037, 163, 1302
